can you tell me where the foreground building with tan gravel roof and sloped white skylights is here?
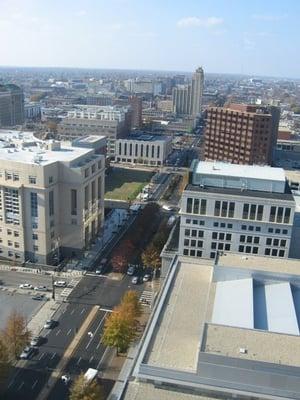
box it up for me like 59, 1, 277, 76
123, 254, 300, 400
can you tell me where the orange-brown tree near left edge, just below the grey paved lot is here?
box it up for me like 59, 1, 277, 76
3, 311, 31, 359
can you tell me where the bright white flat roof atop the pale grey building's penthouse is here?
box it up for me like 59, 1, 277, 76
194, 161, 285, 181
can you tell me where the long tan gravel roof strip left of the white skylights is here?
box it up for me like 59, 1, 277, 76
148, 263, 212, 371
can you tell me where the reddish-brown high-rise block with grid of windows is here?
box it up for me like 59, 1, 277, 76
204, 104, 280, 165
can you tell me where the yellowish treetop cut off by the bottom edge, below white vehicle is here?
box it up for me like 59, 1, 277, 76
69, 373, 105, 400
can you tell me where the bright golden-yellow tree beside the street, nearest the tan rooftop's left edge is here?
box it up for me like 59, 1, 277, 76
101, 308, 136, 353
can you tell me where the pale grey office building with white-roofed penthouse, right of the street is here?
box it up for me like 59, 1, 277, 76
179, 161, 295, 258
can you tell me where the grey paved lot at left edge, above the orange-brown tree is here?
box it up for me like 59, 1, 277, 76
0, 291, 44, 330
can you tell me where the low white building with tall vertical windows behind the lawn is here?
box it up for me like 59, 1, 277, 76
116, 134, 172, 166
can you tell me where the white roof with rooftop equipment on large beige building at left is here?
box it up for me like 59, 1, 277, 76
0, 129, 91, 166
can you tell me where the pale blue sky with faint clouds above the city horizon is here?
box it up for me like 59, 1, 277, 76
0, 0, 300, 78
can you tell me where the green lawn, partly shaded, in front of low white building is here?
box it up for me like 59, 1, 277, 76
105, 168, 153, 200
